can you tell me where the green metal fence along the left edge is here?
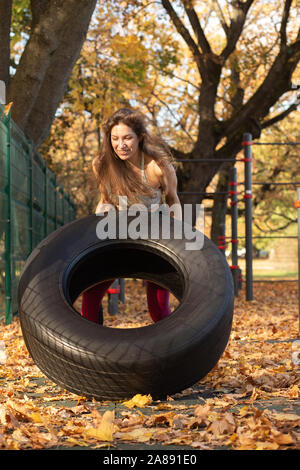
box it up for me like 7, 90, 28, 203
0, 105, 76, 324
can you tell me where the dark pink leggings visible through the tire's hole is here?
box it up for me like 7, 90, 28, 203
81, 280, 171, 323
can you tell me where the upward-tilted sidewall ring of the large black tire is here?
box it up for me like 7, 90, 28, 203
18, 215, 234, 396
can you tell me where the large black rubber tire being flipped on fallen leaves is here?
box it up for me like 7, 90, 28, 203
18, 215, 234, 400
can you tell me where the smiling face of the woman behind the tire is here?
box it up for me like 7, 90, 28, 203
110, 123, 139, 160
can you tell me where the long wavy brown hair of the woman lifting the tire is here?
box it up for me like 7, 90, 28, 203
93, 108, 173, 206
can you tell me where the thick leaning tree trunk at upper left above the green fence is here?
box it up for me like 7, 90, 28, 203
8, 0, 96, 144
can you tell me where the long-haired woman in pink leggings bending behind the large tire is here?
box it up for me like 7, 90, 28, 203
81, 108, 180, 323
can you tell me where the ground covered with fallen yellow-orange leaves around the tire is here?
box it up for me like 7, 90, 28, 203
0, 280, 300, 450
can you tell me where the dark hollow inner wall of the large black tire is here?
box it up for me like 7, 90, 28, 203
62, 240, 187, 314
